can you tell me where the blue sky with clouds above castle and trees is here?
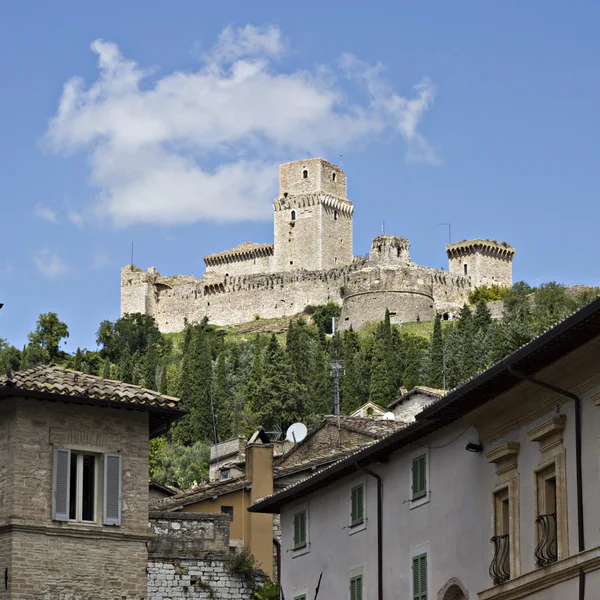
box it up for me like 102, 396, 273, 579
0, 0, 600, 351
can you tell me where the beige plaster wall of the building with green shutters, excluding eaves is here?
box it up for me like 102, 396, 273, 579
281, 340, 600, 600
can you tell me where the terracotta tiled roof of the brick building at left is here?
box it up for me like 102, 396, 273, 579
0, 366, 179, 411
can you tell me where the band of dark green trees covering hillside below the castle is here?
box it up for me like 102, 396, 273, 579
0, 282, 598, 486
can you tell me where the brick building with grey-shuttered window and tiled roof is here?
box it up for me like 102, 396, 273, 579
0, 366, 181, 600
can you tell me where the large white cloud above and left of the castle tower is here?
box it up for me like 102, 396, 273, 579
46, 25, 439, 226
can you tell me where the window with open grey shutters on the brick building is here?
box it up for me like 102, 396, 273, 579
52, 448, 121, 525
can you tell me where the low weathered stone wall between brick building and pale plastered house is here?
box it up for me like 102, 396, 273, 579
148, 513, 260, 600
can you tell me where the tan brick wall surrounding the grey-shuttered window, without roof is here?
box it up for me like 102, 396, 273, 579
0, 398, 149, 600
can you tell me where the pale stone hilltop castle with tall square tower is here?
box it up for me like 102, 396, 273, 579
121, 158, 515, 333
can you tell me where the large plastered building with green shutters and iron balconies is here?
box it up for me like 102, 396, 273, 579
250, 300, 600, 600
